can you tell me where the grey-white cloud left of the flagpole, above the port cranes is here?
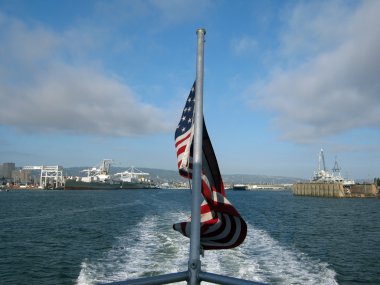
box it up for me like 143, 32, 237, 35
0, 14, 173, 136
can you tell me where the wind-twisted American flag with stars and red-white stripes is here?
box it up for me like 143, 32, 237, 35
173, 82, 247, 250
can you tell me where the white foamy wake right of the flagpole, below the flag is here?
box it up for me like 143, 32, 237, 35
208, 225, 338, 285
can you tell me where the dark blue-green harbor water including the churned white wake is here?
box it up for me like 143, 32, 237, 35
0, 190, 380, 285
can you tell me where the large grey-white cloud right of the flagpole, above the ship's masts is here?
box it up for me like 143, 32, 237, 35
248, 1, 380, 143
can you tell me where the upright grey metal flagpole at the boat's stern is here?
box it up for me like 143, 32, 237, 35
188, 29, 206, 285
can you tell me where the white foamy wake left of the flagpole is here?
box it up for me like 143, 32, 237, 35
77, 213, 188, 285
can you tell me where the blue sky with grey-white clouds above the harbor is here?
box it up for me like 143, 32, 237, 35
0, 0, 380, 180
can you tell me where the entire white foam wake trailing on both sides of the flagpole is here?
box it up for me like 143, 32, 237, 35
77, 213, 338, 285
